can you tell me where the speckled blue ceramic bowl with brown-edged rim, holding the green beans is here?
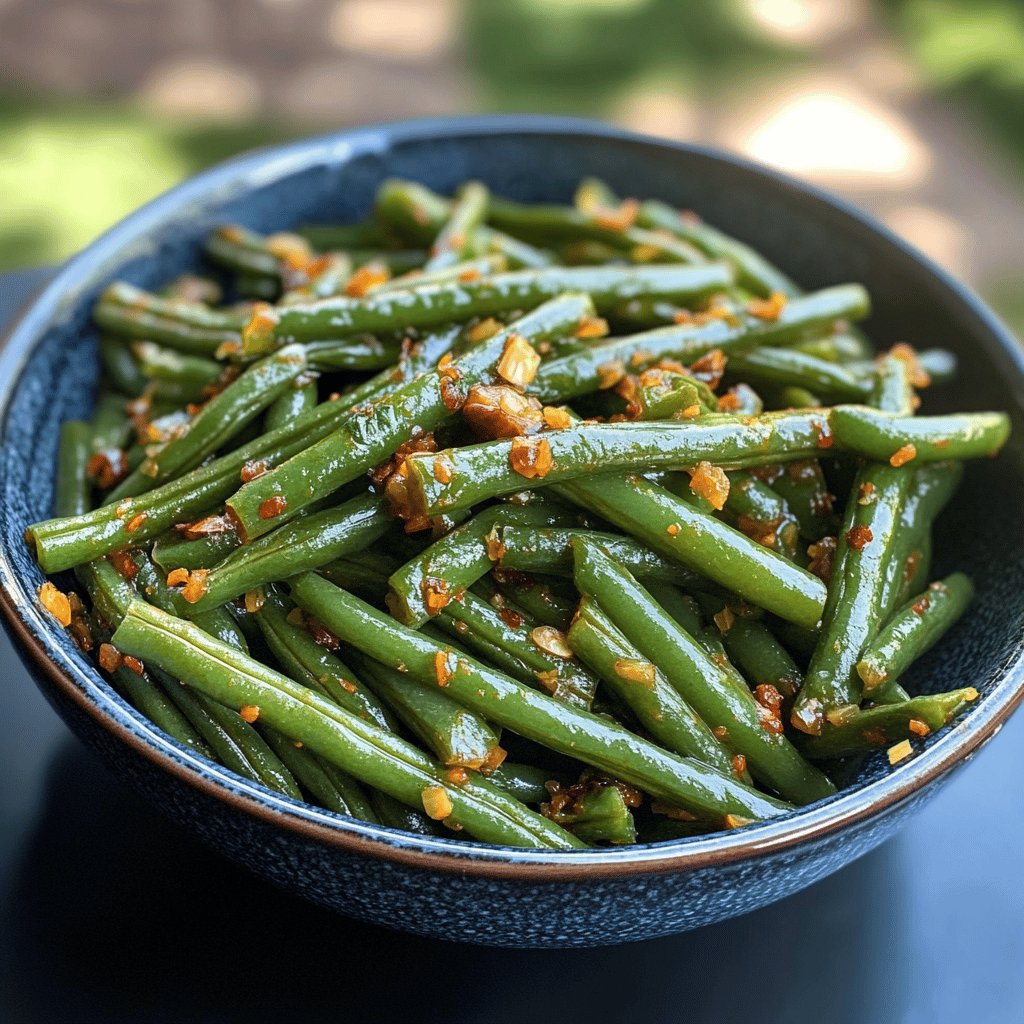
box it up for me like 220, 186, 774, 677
0, 117, 1024, 945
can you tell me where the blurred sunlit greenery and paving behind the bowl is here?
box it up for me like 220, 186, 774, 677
0, 0, 1024, 333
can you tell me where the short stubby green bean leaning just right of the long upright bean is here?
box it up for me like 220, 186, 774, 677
857, 572, 974, 696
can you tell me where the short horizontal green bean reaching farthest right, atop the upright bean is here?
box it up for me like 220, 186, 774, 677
831, 406, 1010, 465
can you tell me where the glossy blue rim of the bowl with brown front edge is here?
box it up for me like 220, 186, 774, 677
0, 114, 1024, 883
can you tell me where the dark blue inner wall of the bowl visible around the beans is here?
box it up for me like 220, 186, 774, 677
0, 119, 1024, 860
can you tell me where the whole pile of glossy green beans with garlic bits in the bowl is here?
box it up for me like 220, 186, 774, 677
26, 179, 1009, 850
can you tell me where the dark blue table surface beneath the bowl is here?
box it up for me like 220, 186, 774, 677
0, 271, 1024, 1024
